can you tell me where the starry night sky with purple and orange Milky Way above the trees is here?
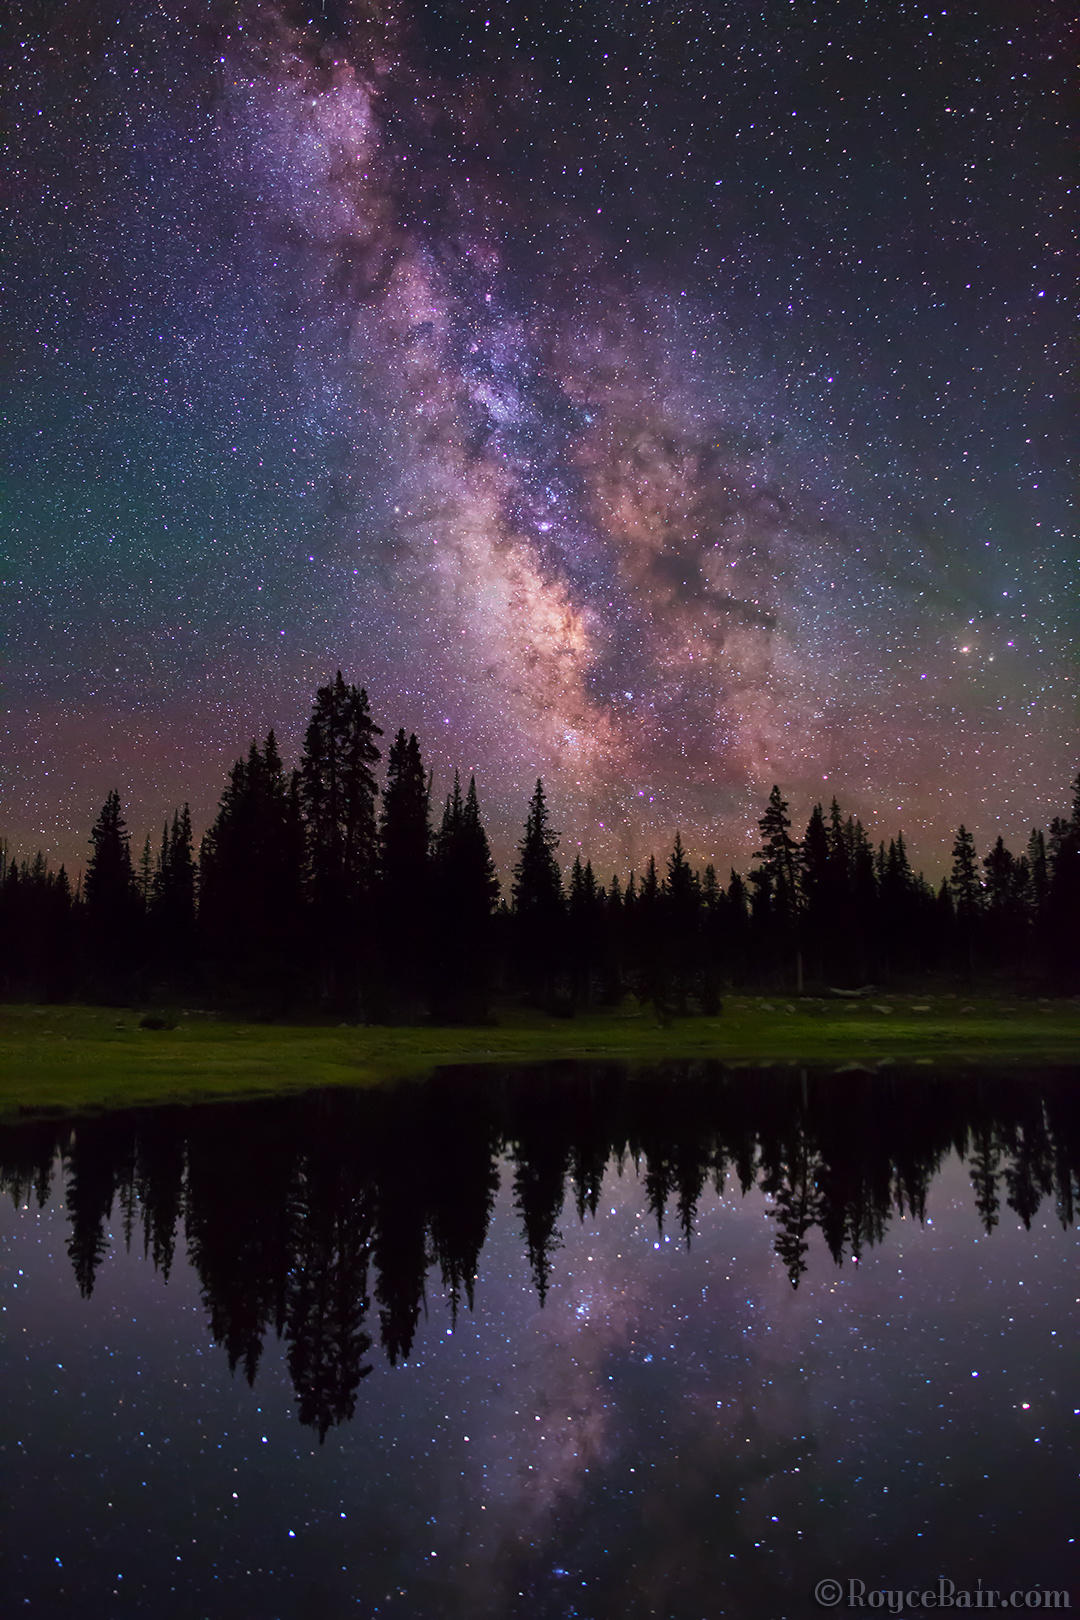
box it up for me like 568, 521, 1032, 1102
0, 0, 1080, 870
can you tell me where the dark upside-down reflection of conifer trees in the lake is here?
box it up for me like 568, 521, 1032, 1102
0, 1064, 1080, 1439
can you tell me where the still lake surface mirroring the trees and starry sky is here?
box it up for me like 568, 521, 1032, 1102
0, 1064, 1080, 1620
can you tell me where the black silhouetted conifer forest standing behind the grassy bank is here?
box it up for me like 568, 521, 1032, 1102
0, 671, 1080, 1021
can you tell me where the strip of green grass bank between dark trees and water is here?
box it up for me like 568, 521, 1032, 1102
0, 995, 1080, 1119
